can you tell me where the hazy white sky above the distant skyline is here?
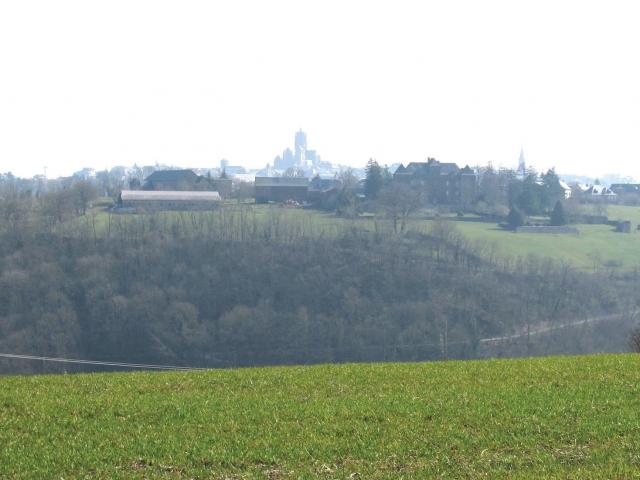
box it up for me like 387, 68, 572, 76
0, 0, 640, 177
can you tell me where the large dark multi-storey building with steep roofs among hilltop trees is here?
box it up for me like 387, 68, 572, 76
393, 158, 478, 207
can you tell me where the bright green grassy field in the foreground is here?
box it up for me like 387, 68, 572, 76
0, 355, 640, 478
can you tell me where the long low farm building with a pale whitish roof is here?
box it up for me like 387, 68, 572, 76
119, 190, 220, 211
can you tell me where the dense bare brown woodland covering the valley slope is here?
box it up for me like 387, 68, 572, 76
0, 185, 640, 373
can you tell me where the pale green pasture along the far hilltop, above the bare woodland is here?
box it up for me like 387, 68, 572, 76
72, 203, 640, 271
